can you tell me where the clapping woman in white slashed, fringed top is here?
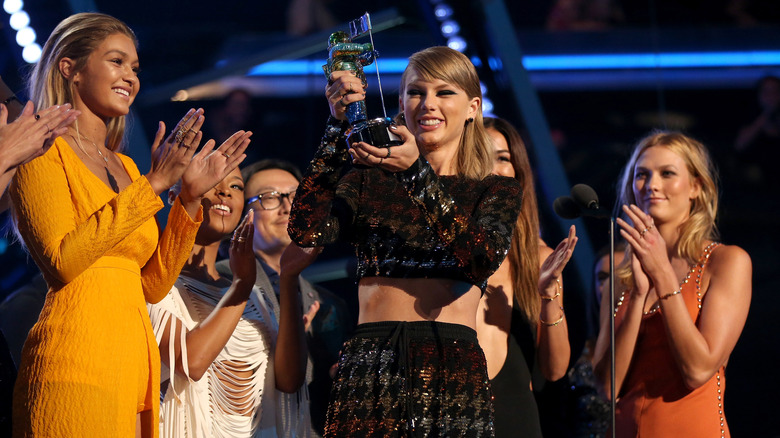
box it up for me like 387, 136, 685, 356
148, 169, 318, 438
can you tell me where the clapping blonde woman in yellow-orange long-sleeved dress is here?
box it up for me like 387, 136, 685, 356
9, 13, 246, 437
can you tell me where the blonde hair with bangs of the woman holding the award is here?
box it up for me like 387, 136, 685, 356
396, 46, 493, 179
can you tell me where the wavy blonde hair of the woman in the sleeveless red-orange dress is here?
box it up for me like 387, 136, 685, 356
617, 131, 718, 287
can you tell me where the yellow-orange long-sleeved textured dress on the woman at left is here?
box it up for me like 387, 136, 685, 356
10, 138, 202, 437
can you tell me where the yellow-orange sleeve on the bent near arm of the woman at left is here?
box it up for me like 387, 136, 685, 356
9, 138, 169, 284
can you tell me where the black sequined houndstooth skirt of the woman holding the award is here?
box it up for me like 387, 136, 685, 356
325, 321, 494, 438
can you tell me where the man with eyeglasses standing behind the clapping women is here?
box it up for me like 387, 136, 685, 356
217, 159, 354, 435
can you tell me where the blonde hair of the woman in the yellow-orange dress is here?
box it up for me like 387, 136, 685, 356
27, 12, 138, 151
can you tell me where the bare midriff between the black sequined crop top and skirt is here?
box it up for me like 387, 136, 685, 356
358, 277, 481, 329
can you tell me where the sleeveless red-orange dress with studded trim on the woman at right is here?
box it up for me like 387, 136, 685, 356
615, 244, 731, 438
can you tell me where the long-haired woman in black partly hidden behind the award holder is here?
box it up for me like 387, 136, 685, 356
477, 117, 577, 438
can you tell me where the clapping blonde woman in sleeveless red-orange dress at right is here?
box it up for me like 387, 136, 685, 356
594, 132, 752, 438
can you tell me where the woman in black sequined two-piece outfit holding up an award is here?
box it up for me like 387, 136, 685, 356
289, 47, 521, 437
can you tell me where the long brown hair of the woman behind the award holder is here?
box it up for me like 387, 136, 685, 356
485, 117, 542, 325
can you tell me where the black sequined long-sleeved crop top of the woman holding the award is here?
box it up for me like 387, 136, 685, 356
288, 118, 522, 289
